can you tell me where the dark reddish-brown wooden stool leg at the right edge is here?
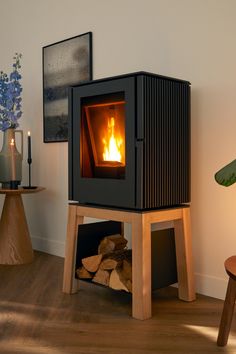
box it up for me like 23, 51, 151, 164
217, 278, 236, 347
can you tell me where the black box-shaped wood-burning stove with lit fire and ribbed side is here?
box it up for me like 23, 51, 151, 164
69, 72, 190, 210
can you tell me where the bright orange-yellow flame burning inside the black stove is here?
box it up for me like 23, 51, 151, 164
102, 117, 123, 162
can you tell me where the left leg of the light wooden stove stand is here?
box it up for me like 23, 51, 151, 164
63, 205, 84, 294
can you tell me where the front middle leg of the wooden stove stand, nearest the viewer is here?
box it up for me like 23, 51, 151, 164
132, 214, 152, 320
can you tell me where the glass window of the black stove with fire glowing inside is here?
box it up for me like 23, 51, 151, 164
81, 95, 125, 179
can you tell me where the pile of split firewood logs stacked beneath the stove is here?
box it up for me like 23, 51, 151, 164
76, 235, 132, 292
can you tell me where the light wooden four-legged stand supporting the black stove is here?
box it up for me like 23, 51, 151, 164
63, 204, 195, 320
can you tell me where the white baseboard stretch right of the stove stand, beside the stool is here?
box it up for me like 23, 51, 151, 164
195, 273, 228, 300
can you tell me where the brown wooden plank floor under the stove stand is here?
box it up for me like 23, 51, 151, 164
0, 252, 236, 354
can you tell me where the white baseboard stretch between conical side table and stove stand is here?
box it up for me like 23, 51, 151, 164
31, 236, 65, 257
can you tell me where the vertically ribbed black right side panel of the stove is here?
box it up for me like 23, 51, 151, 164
142, 76, 190, 209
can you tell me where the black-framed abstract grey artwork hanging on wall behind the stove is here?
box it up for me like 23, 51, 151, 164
43, 32, 92, 143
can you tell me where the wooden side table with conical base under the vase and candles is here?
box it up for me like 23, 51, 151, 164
0, 187, 45, 264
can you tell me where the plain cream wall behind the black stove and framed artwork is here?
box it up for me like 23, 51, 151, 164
0, 0, 236, 297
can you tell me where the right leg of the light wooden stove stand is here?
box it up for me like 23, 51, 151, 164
174, 208, 196, 301
